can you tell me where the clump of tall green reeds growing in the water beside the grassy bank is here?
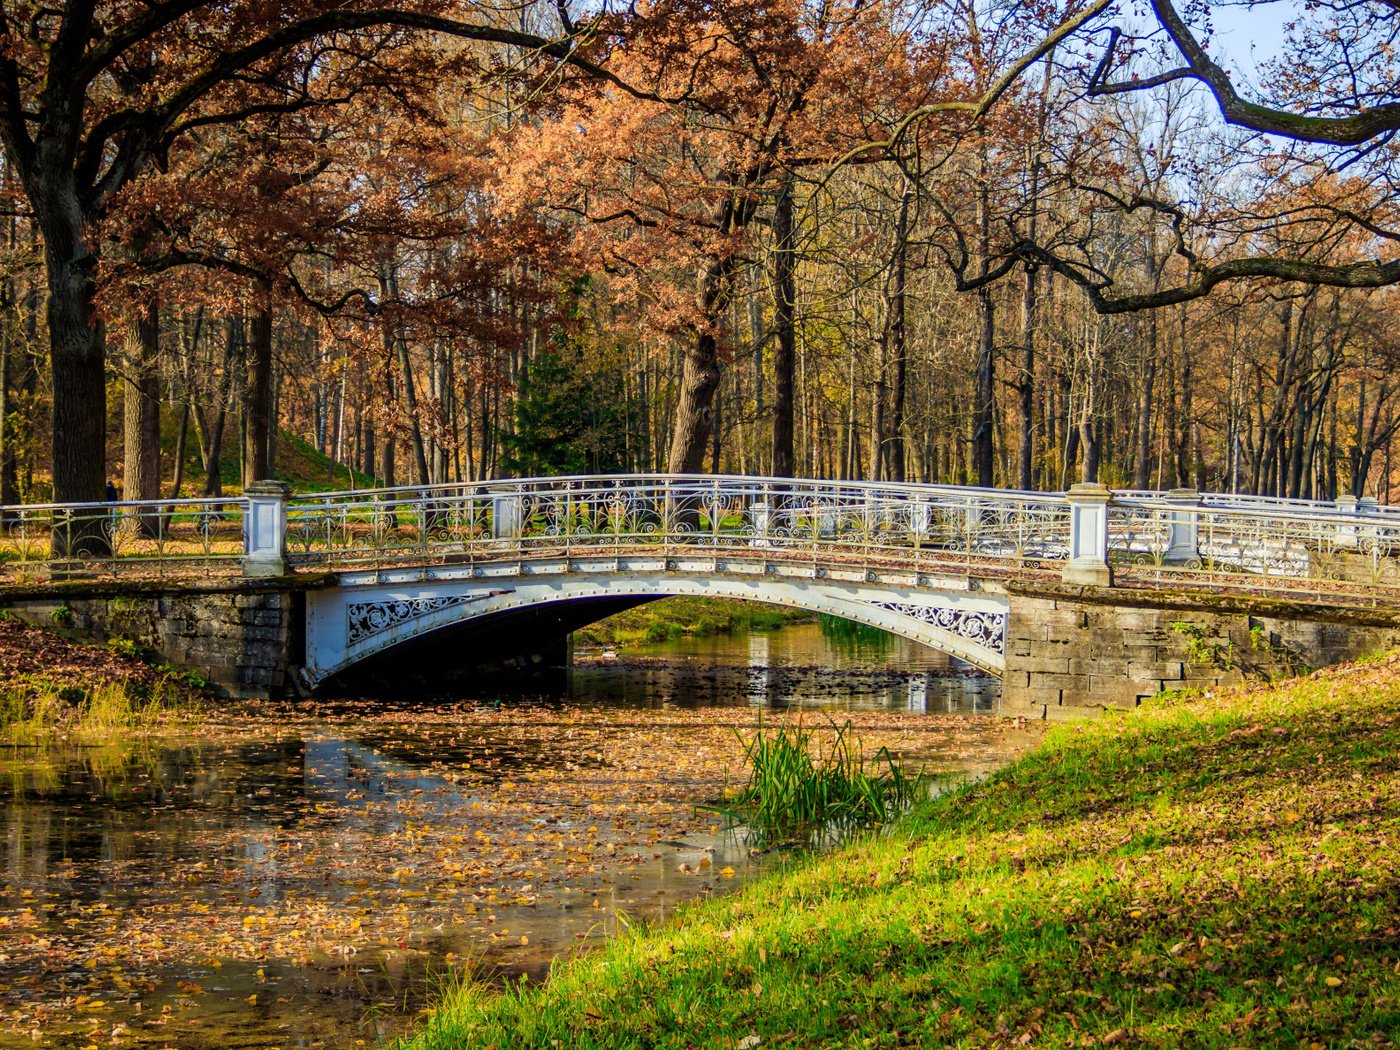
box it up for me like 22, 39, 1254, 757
706, 718, 928, 846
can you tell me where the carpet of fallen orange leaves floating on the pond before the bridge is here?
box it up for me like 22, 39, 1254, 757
0, 701, 1033, 1047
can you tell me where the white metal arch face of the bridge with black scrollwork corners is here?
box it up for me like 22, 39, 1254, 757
304, 566, 1008, 687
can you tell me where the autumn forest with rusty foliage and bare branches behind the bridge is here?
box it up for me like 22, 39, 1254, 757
0, 0, 1400, 504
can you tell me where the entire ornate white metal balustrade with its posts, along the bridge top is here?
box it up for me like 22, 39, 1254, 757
0, 475, 1400, 605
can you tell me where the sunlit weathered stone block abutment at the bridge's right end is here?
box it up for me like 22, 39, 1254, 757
1002, 585, 1400, 718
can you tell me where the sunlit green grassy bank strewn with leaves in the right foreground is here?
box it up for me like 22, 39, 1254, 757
413, 657, 1400, 1050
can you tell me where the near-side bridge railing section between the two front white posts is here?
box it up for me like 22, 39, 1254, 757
278, 475, 1070, 576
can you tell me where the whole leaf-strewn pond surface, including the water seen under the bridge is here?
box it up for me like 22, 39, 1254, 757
0, 624, 1035, 1050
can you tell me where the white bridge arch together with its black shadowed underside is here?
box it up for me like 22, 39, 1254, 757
302, 560, 1008, 692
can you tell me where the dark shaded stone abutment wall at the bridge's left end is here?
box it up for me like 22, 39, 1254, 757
0, 580, 305, 696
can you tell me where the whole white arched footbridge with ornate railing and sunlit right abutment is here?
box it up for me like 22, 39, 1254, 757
0, 475, 1400, 706
